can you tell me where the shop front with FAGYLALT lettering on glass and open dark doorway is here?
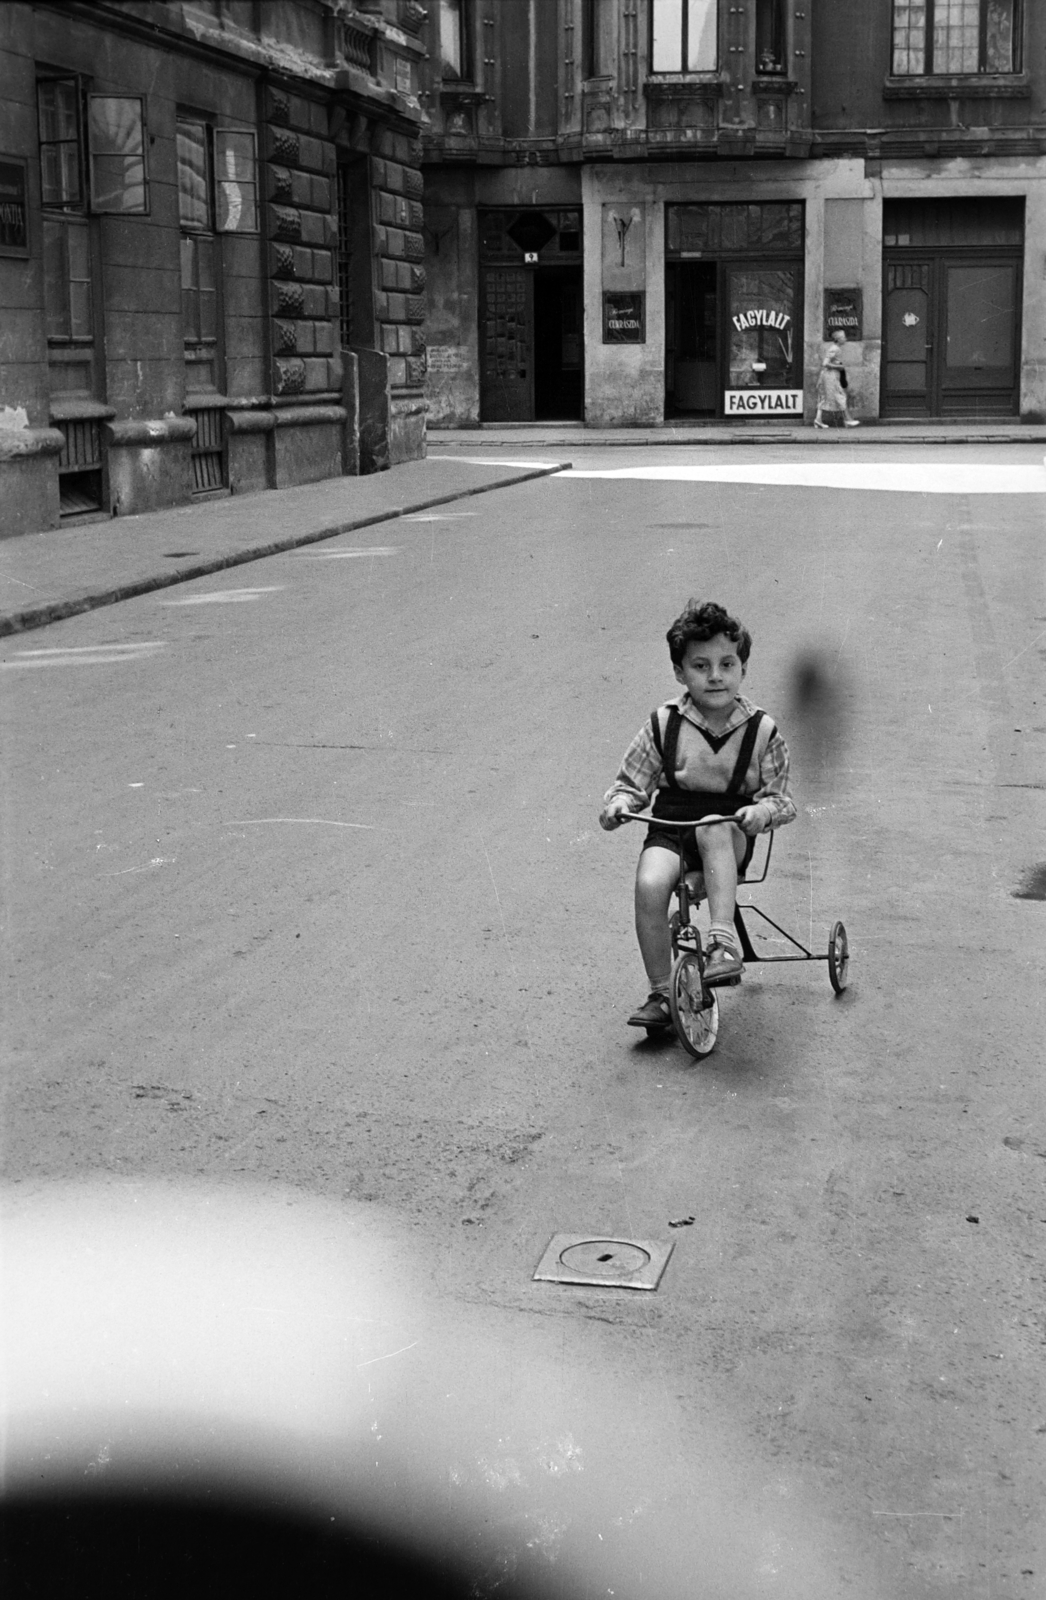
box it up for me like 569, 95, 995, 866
665, 200, 803, 419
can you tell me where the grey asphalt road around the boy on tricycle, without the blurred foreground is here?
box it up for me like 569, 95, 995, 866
0, 446, 1046, 1600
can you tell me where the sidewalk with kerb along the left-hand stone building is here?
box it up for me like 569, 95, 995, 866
0, 454, 569, 637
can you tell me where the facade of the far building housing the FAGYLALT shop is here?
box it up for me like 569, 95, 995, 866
421, 0, 1046, 427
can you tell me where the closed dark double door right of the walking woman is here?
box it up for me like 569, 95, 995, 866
883, 250, 1020, 416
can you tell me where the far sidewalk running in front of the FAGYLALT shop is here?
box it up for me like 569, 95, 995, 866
429, 418, 1046, 451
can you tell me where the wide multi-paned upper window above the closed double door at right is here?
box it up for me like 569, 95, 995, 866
892, 0, 1020, 77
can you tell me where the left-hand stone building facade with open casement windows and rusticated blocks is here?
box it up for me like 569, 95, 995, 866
0, 0, 425, 534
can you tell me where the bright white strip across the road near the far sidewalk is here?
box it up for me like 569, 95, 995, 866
555, 461, 1046, 494
